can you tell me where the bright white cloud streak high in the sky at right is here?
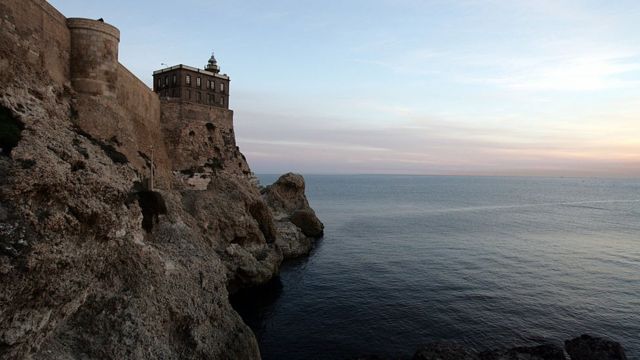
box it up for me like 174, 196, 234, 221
356, 42, 640, 92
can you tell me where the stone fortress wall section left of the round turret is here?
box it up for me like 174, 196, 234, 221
0, 0, 71, 85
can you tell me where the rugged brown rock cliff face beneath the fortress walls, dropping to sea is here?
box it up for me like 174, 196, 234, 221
0, 5, 322, 359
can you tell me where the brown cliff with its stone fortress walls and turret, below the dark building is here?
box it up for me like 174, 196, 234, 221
0, 0, 322, 359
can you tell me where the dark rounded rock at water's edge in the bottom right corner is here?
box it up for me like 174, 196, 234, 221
564, 335, 627, 360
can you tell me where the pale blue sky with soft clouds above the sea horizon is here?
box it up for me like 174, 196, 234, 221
50, 0, 640, 177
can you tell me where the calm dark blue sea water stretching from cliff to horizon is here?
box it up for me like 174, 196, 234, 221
235, 176, 640, 359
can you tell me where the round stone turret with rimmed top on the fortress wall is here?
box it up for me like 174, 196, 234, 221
67, 18, 120, 97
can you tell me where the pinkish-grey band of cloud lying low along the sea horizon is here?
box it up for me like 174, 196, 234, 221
236, 101, 640, 176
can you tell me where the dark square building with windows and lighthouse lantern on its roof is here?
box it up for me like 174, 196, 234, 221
153, 54, 229, 109
